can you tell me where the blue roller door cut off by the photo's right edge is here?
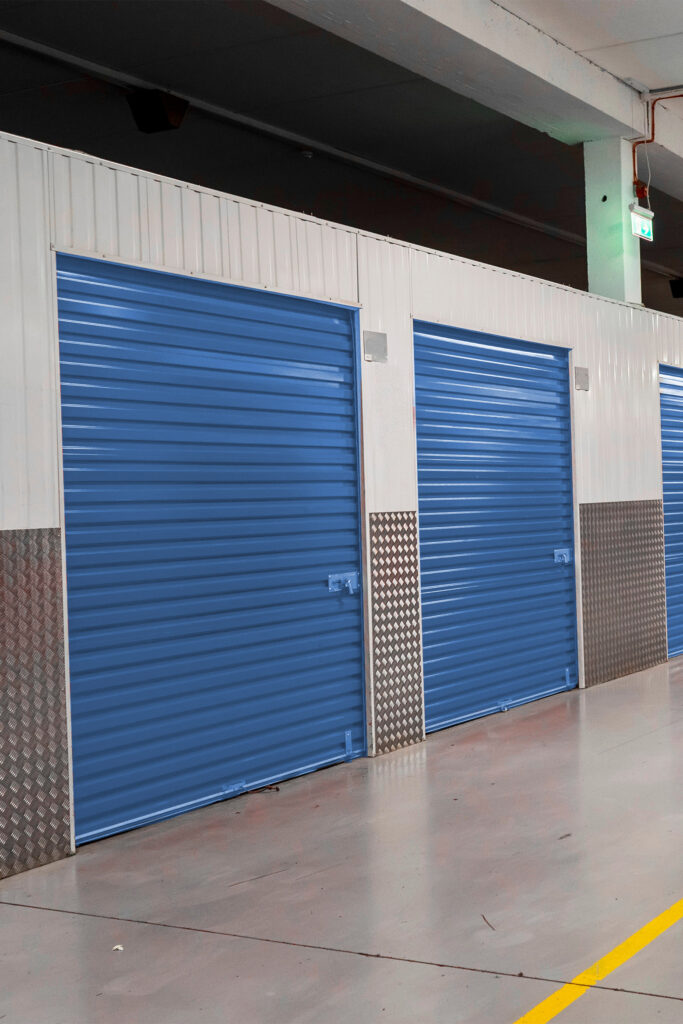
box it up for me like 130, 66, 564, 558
659, 367, 683, 657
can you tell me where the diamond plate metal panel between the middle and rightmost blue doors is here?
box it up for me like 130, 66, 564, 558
581, 501, 667, 686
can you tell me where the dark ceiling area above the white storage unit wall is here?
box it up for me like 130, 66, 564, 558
0, 0, 683, 312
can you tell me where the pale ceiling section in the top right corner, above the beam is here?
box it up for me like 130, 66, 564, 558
499, 0, 683, 90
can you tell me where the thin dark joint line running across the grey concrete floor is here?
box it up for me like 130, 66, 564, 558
0, 899, 683, 1002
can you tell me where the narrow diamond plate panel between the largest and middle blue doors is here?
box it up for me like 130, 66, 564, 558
370, 512, 425, 754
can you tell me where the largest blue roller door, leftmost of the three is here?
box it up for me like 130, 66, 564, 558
57, 256, 366, 842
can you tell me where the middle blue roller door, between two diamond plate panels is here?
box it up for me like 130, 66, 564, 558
415, 323, 578, 730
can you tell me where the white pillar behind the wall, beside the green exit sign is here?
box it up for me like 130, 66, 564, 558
584, 138, 642, 302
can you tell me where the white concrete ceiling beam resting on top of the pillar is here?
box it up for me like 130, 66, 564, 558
269, 0, 683, 199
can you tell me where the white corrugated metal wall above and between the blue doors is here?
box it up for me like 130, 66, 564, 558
0, 125, 683, 704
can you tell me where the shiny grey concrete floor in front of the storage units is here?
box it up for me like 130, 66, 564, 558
0, 660, 683, 1024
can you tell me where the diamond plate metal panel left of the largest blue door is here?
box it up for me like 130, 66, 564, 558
0, 529, 71, 879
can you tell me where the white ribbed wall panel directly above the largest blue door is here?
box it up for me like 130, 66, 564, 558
49, 153, 357, 302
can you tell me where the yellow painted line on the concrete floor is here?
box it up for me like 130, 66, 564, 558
514, 899, 683, 1024
